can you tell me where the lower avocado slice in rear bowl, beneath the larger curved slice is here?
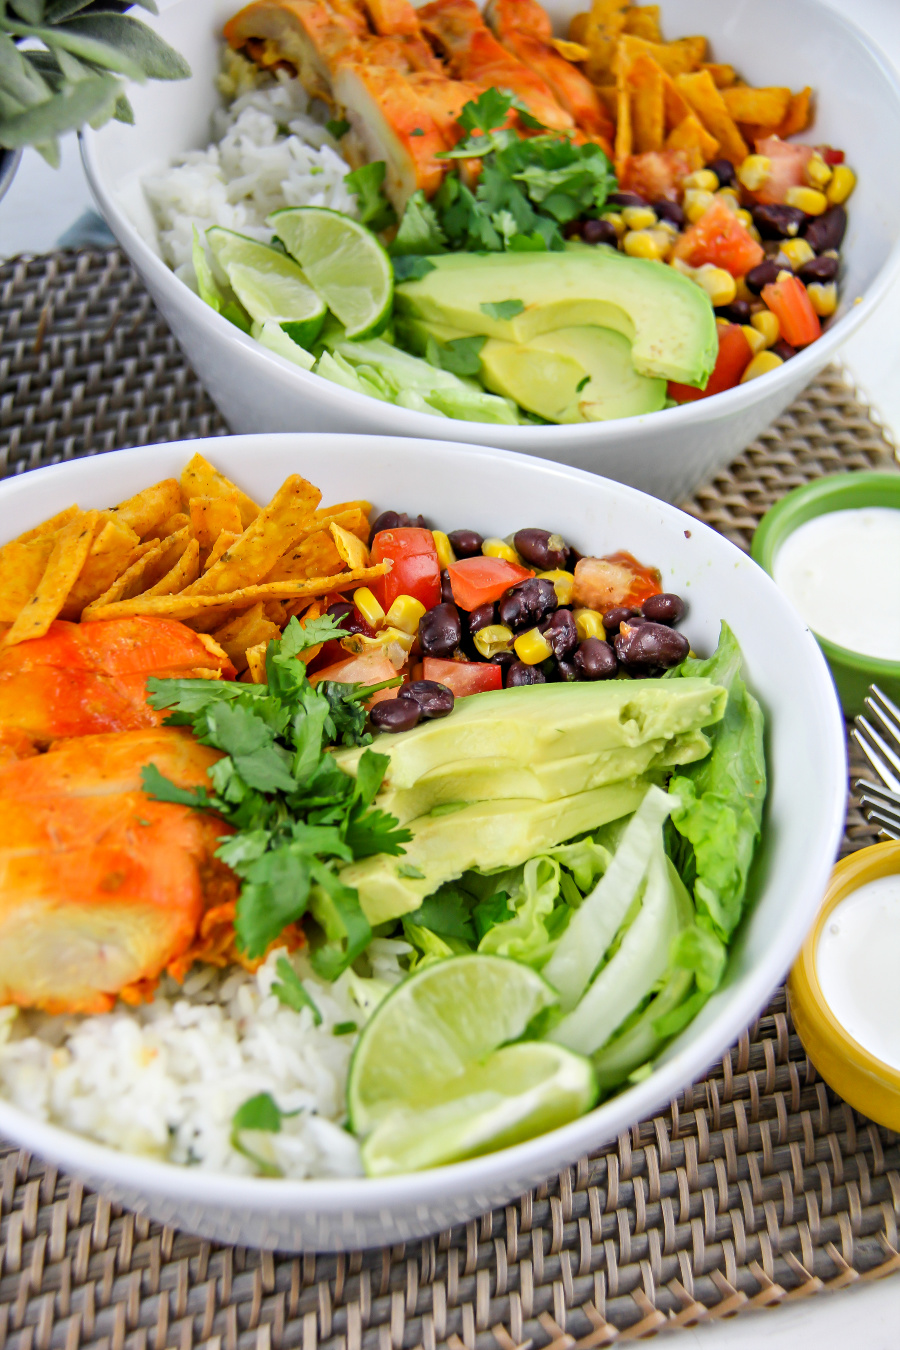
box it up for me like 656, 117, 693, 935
480, 324, 665, 423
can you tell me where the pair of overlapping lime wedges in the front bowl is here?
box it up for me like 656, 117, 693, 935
347, 956, 596, 1176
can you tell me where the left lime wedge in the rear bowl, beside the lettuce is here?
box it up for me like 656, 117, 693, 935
206, 225, 328, 347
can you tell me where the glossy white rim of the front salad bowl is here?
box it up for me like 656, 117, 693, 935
0, 432, 846, 1214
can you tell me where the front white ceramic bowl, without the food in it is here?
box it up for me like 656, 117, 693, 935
0, 435, 846, 1250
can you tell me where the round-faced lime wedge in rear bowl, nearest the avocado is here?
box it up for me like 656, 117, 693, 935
269, 207, 394, 338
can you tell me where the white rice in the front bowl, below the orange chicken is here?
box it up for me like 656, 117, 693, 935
0, 938, 410, 1177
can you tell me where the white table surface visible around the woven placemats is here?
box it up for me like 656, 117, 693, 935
0, 0, 900, 1350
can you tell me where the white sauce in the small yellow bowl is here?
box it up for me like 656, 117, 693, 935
815, 875, 900, 1069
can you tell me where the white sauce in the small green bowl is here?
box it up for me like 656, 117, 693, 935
773, 506, 900, 662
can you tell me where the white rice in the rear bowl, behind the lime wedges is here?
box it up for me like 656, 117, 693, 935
143, 53, 358, 282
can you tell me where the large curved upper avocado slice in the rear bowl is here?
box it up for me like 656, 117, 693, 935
394, 246, 718, 387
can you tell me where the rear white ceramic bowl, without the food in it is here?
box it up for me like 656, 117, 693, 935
82, 0, 900, 501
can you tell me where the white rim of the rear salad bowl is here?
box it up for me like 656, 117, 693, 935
78, 0, 900, 450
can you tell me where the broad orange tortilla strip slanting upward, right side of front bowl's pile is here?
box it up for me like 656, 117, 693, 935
183, 474, 321, 595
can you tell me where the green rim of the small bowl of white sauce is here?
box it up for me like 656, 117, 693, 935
750, 468, 900, 684
